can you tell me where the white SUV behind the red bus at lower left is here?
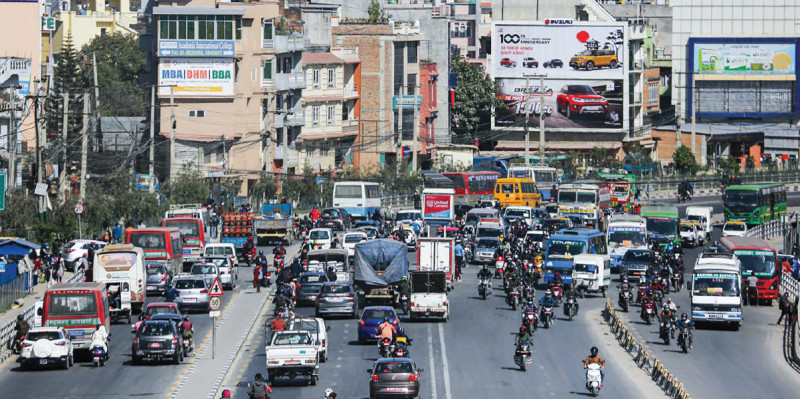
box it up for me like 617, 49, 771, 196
20, 327, 74, 370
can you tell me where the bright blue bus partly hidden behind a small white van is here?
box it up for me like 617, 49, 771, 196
544, 229, 608, 284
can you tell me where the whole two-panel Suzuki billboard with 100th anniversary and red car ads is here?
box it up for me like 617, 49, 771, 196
491, 20, 628, 131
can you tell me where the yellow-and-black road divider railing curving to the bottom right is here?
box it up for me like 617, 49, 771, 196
603, 299, 691, 399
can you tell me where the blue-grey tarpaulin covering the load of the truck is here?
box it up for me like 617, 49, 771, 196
353, 239, 408, 287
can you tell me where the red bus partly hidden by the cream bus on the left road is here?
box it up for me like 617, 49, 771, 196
125, 227, 184, 271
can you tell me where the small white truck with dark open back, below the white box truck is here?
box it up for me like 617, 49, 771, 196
408, 270, 450, 321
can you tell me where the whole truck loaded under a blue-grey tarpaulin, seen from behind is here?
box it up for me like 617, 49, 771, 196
353, 239, 408, 306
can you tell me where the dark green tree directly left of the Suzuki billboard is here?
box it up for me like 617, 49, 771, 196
450, 58, 505, 143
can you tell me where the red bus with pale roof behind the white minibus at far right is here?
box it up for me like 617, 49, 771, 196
719, 237, 780, 305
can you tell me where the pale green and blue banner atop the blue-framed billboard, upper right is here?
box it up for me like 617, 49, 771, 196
693, 42, 796, 75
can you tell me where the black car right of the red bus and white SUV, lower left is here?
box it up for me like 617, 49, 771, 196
131, 320, 183, 364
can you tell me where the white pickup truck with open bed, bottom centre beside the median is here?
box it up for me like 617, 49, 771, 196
265, 331, 319, 386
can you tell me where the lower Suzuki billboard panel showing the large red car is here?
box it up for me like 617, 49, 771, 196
494, 78, 625, 130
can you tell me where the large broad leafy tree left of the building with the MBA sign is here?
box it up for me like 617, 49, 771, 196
81, 33, 146, 116
